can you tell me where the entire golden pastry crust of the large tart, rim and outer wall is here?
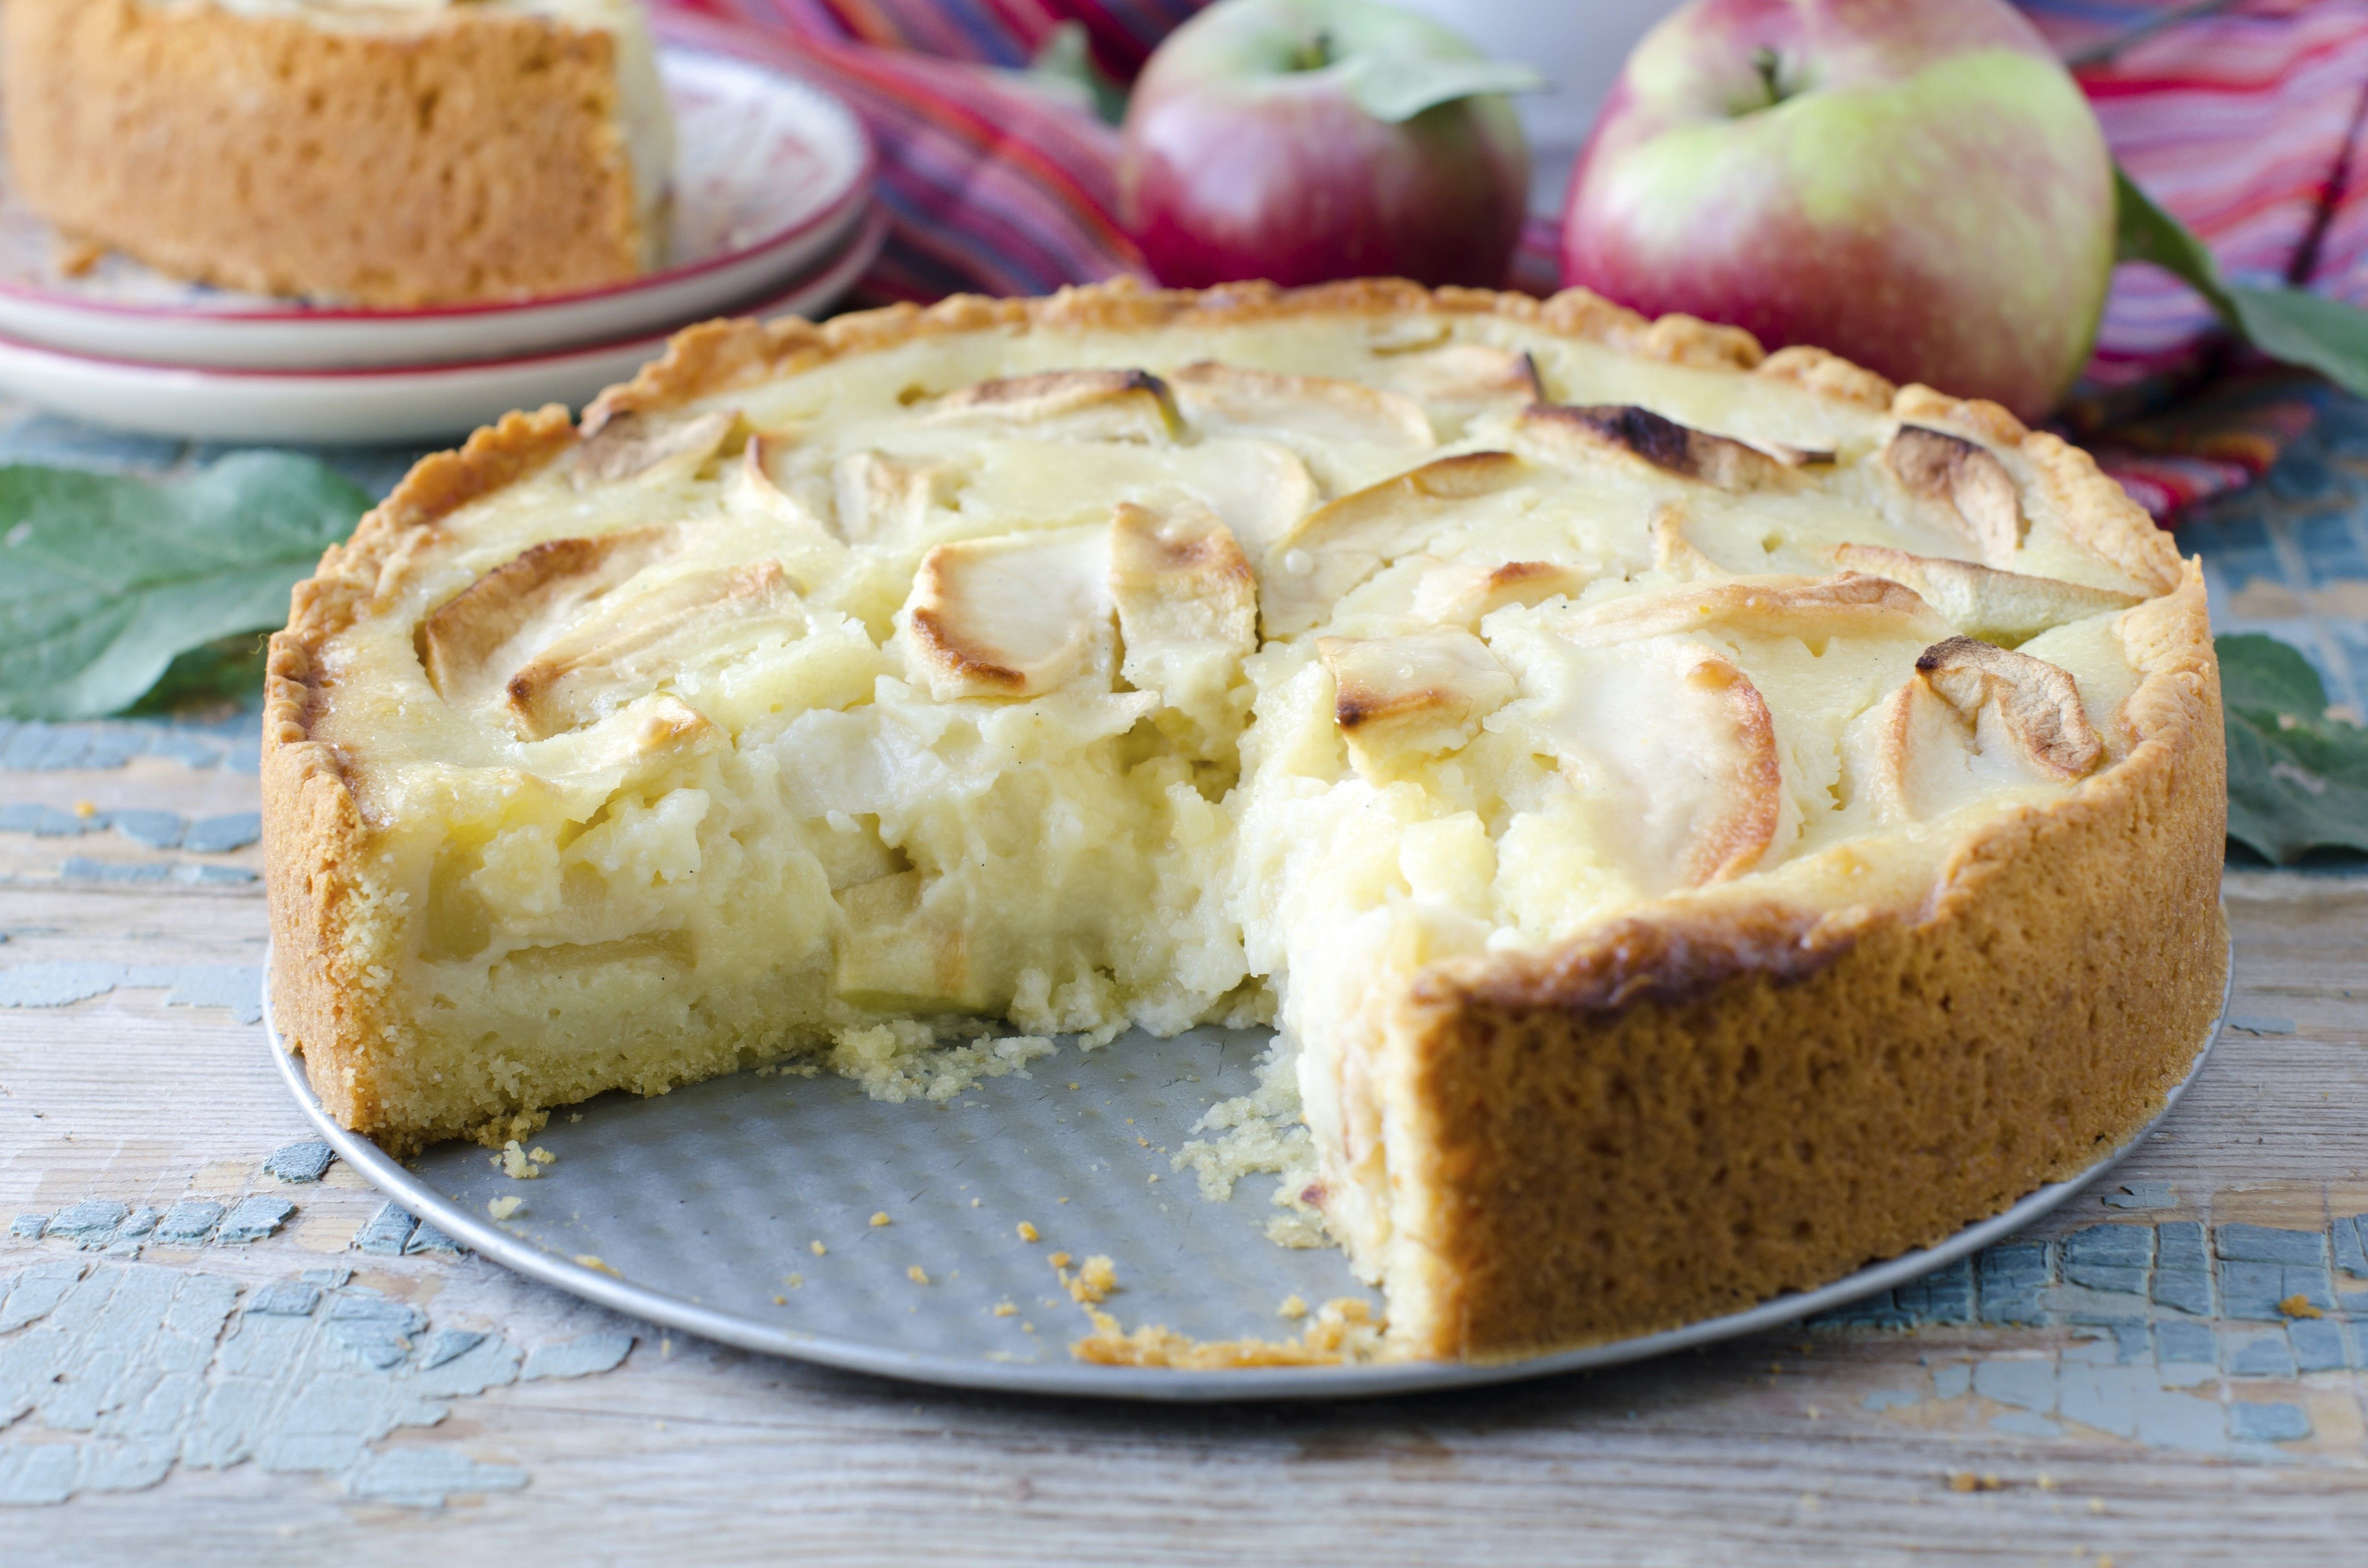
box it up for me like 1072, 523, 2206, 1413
263, 282, 2228, 1360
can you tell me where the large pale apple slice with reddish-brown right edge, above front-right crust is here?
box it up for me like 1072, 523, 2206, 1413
1542, 637, 1783, 893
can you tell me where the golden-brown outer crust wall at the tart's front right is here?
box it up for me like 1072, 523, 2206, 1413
1378, 566, 2228, 1357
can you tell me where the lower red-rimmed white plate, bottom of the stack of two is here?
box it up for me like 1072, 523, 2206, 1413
0, 211, 888, 445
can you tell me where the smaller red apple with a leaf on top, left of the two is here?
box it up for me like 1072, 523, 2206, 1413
1120, 0, 1537, 287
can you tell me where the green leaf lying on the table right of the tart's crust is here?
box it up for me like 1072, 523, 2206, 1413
2214, 635, 2368, 865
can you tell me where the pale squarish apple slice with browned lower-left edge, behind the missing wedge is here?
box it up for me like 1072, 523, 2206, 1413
898, 526, 1113, 701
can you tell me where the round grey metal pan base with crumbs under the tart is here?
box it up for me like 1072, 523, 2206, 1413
263, 952, 2228, 1400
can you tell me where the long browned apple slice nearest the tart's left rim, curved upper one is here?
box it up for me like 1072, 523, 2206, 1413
412, 528, 670, 703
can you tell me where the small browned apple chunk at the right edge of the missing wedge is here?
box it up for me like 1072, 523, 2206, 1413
1317, 630, 1513, 779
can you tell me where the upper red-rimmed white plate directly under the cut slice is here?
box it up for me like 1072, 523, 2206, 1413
0, 48, 872, 369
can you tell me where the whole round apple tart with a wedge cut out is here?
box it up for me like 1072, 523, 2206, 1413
263, 282, 2226, 1357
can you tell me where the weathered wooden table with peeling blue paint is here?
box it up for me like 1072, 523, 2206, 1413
0, 405, 2368, 1568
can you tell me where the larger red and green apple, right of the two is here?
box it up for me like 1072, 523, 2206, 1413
1563, 0, 2112, 419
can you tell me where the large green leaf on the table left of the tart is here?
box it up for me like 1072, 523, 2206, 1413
0, 453, 370, 718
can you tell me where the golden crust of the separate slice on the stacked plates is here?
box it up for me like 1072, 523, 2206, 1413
0, 0, 649, 306
